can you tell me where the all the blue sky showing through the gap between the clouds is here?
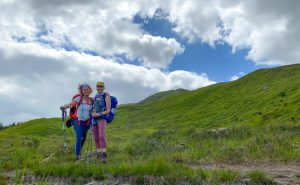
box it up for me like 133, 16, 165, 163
133, 15, 275, 82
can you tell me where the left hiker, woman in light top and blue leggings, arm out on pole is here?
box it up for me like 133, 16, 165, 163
60, 84, 93, 161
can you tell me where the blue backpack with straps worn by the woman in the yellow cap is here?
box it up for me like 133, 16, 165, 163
94, 93, 118, 123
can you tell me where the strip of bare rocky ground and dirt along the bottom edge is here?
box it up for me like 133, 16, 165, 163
2, 162, 300, 185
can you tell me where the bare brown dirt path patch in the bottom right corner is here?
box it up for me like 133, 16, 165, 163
190, 162, 300, 185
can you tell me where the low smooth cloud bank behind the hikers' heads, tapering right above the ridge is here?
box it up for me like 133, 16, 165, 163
0, 41, 215, 123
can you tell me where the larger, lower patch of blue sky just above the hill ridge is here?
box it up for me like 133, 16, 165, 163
170, 43, 258, 82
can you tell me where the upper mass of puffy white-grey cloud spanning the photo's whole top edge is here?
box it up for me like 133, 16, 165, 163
0, 0, 300, 68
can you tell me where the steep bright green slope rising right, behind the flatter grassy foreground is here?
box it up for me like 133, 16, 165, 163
122, 65, 300, 131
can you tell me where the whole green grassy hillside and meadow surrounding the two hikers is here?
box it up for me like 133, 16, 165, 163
0, 65, 300, 184
